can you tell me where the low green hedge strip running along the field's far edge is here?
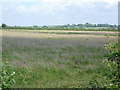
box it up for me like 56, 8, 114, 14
3, 26, 118, 31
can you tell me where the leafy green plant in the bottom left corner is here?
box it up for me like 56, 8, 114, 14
0, 63, 16, 88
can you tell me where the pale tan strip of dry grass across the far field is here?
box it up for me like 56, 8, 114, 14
2, 30, 116, 38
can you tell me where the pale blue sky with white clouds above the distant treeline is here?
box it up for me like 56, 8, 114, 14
0, 0, 119, 26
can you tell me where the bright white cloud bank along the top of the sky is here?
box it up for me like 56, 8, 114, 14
2, 0, 119, 14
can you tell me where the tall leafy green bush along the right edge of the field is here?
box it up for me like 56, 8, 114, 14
105, 43, 120, 88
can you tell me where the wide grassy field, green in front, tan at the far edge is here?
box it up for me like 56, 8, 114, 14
2, 30, 117, 88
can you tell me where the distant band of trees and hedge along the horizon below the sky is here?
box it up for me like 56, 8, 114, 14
1, 23, 117, 30
